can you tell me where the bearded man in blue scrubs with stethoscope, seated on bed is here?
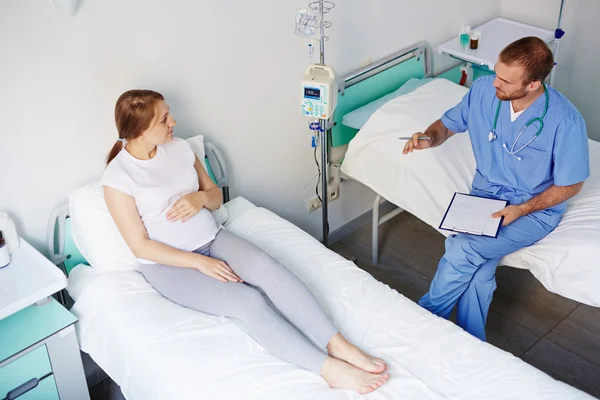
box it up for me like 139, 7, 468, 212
403, 37, 590, 341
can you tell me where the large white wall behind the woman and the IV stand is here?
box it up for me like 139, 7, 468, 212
0, 0, 500, 253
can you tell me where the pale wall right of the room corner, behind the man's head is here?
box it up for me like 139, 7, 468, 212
502, 0, 600, 141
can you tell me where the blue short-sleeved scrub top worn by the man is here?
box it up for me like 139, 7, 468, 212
441, 75, 590, 228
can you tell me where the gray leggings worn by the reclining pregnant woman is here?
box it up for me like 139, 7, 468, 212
141, 229, 337, 373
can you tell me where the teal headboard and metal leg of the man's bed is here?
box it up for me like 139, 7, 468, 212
329, 42, 494, 265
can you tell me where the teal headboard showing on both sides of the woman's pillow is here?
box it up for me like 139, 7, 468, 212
46, 142, 229, 276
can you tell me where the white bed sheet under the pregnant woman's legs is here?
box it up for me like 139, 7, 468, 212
69, 198, 592, 400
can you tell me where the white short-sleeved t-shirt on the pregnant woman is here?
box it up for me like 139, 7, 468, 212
102, 138, 219, 264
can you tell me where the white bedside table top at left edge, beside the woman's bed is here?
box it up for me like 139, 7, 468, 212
0, 238, 67, 319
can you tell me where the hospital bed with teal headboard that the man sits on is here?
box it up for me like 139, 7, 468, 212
332, 43, 600, 306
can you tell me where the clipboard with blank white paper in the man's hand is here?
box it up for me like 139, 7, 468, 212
438, 192, 509, 238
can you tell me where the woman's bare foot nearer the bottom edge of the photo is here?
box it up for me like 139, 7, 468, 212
321, 357, 390, 394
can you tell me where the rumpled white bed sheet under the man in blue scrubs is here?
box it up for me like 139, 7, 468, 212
342, 79, 600, 307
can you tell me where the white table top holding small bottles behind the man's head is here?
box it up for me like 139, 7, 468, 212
438, 18, 554, 71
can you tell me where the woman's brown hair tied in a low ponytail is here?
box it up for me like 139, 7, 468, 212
106, 89, 165, 165
